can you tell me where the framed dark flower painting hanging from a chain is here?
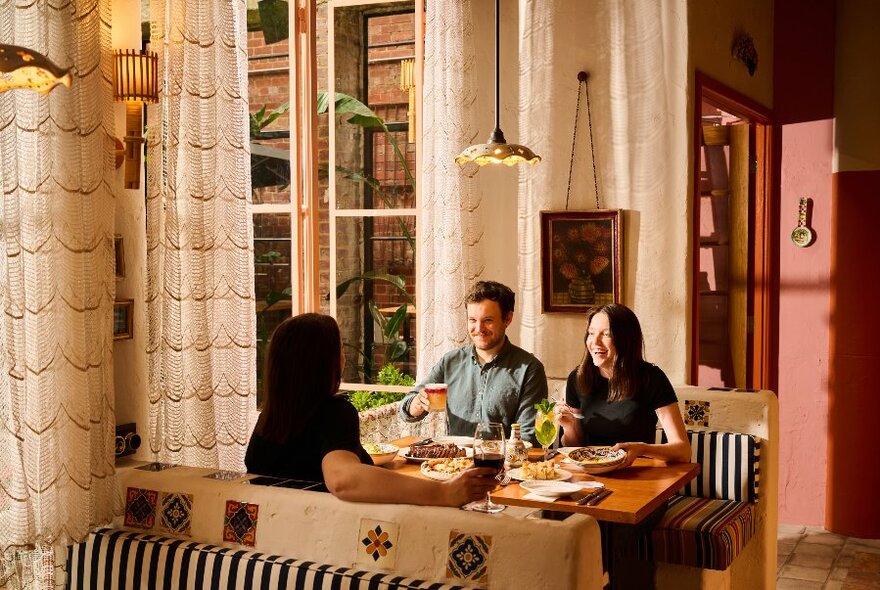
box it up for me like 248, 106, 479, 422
541, 209, 623, 313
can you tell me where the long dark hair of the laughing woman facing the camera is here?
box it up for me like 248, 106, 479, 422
577, 303, 644, 401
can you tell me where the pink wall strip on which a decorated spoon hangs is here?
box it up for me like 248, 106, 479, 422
778, 120, 833, 525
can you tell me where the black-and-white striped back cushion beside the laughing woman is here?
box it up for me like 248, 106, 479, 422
656, 428, 761, 502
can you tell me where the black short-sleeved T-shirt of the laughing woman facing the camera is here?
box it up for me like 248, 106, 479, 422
565, 362, 678, 445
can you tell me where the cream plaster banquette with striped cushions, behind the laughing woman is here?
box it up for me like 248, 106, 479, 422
550, 381, 779, 589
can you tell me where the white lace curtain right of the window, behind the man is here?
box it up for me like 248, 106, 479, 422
418, 0, 485, 375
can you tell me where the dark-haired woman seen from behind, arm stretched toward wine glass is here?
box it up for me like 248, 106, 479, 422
245, 313, 496, 506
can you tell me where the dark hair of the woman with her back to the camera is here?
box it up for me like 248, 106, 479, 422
255, 313, 342, 443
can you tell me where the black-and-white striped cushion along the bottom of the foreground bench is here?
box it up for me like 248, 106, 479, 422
67, 529, 482, 590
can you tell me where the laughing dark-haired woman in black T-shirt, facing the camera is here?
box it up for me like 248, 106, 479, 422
559, 303, 691, 466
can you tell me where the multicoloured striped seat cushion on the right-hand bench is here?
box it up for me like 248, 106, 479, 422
631, 496, 756, 570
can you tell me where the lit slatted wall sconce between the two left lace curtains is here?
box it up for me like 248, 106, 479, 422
113, 49, 159, 189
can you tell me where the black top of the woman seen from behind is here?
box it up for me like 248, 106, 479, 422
244, 395, 373, 481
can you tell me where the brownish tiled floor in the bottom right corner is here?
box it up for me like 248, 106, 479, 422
776, 525, 880, 590
